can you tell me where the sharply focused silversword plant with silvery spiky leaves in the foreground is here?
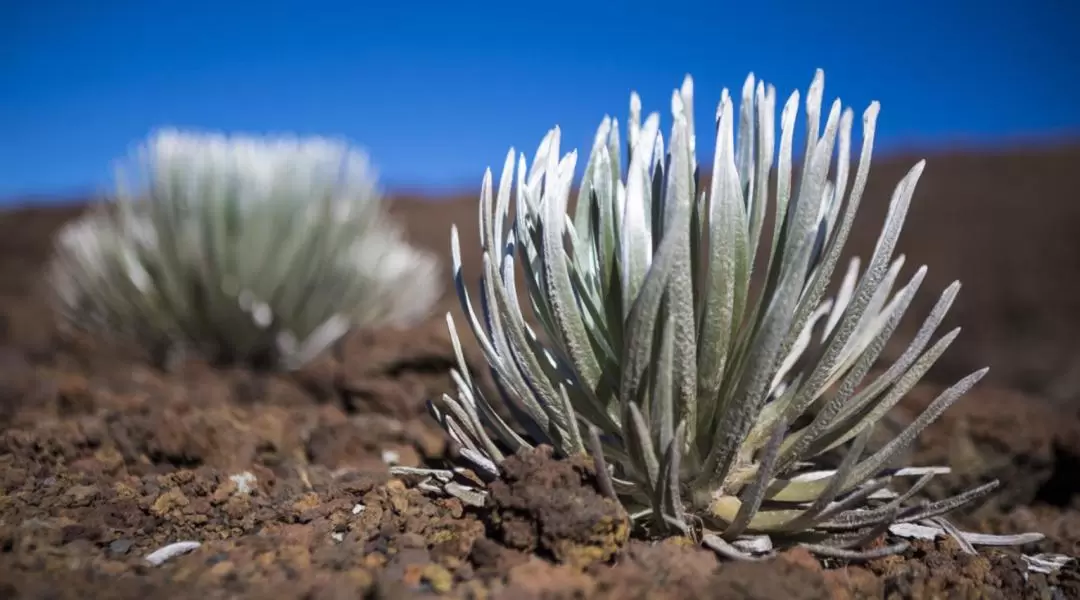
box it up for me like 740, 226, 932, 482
432, 71, 1041, 558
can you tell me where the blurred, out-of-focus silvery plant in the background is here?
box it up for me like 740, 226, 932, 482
48, 129, 442, 368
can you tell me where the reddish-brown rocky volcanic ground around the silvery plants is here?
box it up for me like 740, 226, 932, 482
0, 146, 1080, 599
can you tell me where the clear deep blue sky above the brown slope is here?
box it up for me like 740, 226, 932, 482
0, 0, 1080, 199
